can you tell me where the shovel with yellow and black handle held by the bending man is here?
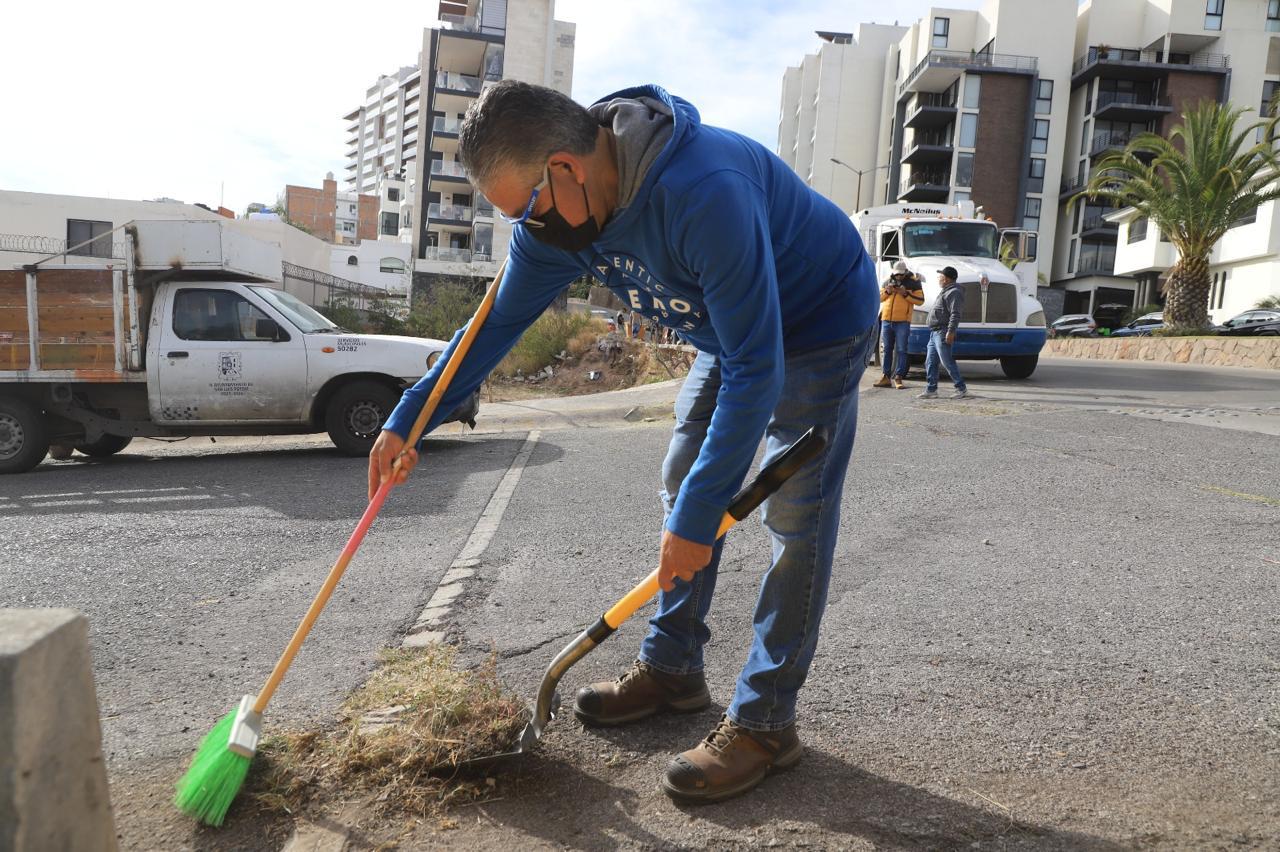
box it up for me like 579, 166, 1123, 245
460, 426, 827, 773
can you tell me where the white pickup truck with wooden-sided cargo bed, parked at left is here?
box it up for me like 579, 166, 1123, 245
0, 221, 479, 473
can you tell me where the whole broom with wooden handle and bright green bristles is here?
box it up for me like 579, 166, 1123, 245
174, 262, 506, 825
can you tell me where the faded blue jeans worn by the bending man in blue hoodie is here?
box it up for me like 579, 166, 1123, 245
640, 329, 876, 730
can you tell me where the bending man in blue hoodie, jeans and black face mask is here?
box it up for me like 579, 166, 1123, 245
369, 81, 878, 802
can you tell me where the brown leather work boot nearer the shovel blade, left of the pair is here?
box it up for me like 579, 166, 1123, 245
573, 660, 712, 727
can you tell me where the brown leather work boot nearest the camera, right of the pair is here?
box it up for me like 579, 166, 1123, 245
662, 716, 804, 805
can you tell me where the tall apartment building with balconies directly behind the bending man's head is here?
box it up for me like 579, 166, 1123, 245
413, 0, 576, 284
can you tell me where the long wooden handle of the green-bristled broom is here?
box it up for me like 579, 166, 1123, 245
253, 261, 507, 714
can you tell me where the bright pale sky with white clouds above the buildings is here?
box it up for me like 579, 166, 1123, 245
0, 0, 980, 212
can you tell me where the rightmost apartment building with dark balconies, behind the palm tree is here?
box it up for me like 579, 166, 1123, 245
1053, 0, 1280, 319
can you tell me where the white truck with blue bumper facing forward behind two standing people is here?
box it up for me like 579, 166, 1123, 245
851, 201, 1047, 379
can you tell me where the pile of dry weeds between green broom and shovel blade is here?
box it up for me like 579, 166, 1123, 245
248, 646, 529, 815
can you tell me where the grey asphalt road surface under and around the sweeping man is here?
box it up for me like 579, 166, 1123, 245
0, 361, 1280, 848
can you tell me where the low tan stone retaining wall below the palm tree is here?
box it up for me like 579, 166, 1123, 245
1044, 336, 1280, 370
